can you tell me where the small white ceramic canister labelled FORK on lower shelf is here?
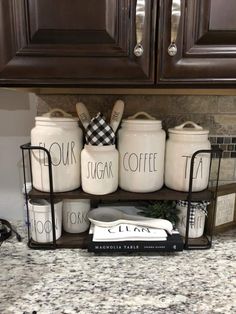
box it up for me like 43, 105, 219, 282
62, 199, 90, 233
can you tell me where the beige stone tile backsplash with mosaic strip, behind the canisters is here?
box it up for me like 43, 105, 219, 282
37, 94, 236, 185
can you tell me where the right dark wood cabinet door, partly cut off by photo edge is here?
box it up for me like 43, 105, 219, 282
158, 0, 236, 87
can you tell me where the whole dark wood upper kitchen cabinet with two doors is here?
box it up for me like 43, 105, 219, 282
0, 0, 236, 88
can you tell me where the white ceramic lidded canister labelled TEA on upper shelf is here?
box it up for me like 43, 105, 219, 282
165, 121, 211, 192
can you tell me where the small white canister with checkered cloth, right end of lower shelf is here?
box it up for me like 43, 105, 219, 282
176, 201, 209, 238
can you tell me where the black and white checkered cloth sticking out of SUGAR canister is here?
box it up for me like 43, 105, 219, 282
85, 112, 115, 146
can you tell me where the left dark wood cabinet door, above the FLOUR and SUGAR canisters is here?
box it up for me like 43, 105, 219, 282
0, 0, 157, 86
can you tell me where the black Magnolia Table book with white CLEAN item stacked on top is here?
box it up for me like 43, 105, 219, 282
88, 223, 183, 253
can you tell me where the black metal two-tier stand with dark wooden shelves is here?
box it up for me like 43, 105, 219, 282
21, 143, 222, 250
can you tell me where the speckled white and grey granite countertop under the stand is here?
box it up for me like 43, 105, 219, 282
0, 224, 236, 314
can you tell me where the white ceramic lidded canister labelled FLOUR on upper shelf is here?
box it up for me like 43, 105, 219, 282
31, 108, 82, 192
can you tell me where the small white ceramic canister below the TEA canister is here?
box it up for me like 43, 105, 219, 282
176, 203, 206, 238
